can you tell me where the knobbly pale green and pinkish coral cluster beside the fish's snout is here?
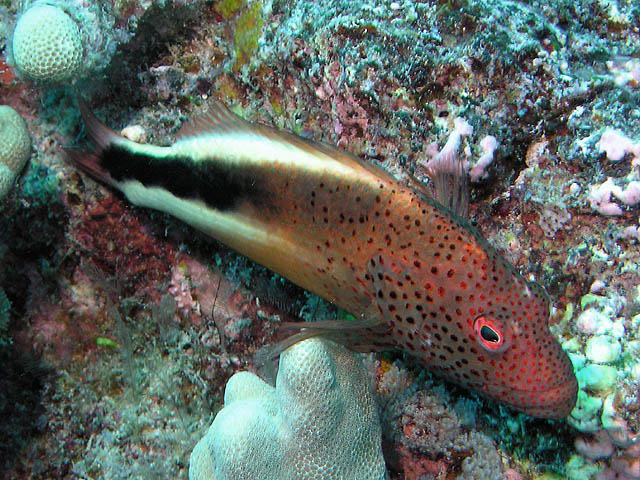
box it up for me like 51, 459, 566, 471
565, 286, 640, 478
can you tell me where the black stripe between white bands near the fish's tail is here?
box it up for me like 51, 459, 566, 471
100, 144, 267, 210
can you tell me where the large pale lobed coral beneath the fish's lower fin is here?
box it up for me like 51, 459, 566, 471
189, 338, 386, 480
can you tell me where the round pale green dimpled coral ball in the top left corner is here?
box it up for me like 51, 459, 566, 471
13, 4, 84, 82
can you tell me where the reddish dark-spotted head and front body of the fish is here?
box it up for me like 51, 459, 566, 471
262, 164, 576, 417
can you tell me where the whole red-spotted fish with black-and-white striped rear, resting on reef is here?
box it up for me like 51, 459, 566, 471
66, 98, 578, 418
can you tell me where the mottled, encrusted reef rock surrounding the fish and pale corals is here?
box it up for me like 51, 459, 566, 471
0, 0, 640, 480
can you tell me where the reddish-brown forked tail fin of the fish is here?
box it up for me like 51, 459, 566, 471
63, 94, 127, 187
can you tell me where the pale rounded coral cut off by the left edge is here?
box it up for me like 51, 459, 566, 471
0, 105, 31, 200
